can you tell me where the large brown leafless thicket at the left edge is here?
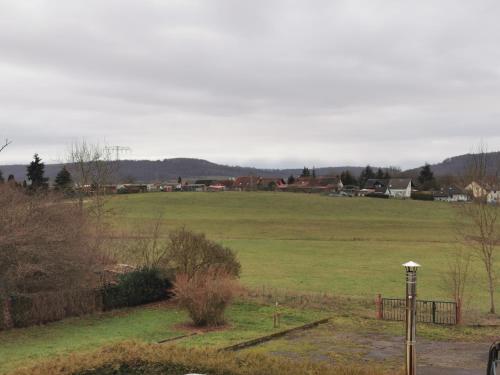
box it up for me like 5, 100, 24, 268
0, 184, 102, 294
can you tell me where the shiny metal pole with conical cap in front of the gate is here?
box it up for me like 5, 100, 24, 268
403, 261, 420, 375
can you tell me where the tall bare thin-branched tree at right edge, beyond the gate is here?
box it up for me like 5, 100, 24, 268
457, 146, 500, 314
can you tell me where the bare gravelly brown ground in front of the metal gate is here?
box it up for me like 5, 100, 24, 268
249, 324, 490, 375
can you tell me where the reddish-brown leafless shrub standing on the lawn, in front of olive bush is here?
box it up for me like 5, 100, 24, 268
174, 268, 240, 326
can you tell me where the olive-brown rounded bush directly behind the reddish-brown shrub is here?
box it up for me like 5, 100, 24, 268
168, 228, 241, 277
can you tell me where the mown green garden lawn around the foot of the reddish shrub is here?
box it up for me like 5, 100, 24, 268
0, 302, 326, 373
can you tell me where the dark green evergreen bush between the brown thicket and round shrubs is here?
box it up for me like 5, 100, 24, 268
102, 268, 172, 310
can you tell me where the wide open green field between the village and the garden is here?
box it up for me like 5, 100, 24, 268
111, 192, 496, 310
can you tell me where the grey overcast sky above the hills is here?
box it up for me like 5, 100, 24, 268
0, 0, 500, 168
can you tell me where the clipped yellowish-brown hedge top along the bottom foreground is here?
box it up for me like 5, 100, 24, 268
11, 342, 402, 375
